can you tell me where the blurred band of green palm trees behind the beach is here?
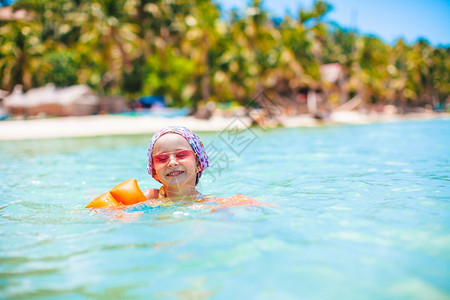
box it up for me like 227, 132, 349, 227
0, 0, 450, 109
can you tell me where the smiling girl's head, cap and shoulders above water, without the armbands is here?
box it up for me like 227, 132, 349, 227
144, 126, 209, 200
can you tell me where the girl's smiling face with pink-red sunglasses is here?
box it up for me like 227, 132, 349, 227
153, 133, 200, 189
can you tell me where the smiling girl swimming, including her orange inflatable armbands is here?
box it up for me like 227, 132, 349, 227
86, 126, 261, 208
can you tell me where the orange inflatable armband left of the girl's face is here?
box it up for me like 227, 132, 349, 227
86, 178, 147, 208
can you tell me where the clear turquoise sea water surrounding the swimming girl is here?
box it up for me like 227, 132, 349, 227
0, 119, 450, 299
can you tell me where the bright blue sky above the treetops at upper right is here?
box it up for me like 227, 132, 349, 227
214, 0, 450, 46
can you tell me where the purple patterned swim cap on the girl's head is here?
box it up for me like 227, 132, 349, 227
147, 126, 209, 180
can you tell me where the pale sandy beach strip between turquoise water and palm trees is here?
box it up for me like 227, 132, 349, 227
0, 112, 450, 141
